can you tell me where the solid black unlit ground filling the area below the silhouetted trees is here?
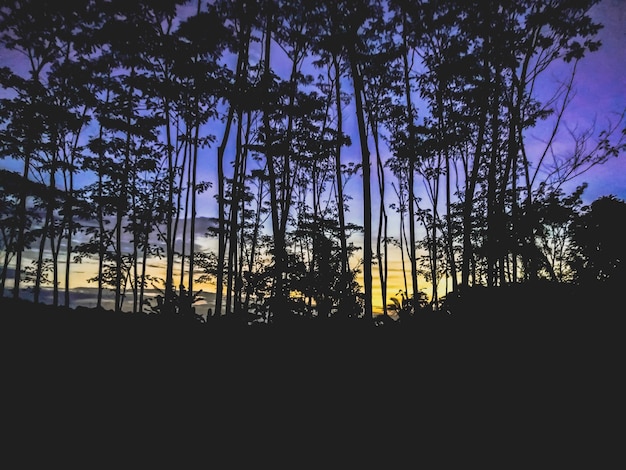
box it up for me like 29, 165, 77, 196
0, 289, 626, 468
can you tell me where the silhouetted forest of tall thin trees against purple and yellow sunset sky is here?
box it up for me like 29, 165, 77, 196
0, 0, 626, 330
